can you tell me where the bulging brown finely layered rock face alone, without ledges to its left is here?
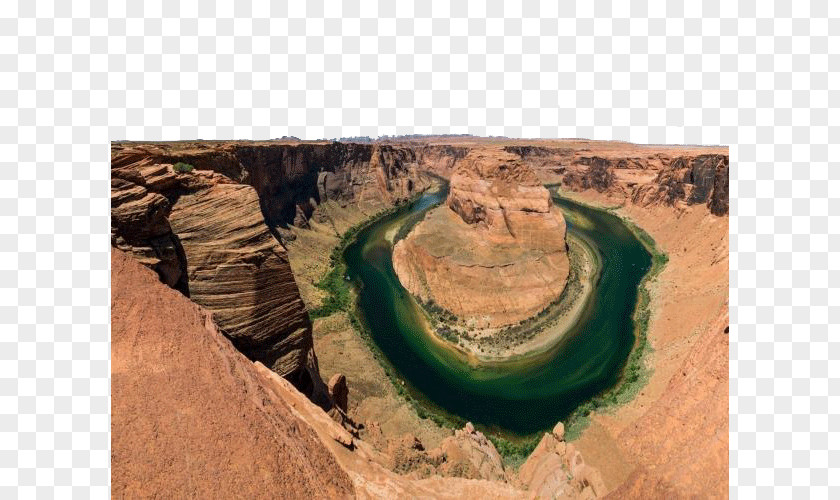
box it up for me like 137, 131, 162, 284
169, 182, 327, 405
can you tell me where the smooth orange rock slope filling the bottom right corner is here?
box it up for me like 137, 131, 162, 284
613, 304, 729, 498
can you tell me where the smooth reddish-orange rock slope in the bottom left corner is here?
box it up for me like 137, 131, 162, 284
111, 249, 354, 498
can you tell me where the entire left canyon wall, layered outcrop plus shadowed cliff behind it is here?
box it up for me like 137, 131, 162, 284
111, 142, 446, 407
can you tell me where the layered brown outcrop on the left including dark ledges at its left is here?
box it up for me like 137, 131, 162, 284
111, 154, 330, 407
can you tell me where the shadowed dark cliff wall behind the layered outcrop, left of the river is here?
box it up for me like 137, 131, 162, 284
112, 141, 440, 228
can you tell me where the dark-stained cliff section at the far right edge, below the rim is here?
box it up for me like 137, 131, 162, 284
632, 155, 729, 215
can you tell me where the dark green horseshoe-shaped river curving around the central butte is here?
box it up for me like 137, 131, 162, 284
344, 189, 651, 436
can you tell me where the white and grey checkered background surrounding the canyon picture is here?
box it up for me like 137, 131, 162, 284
0, 0, 840, 498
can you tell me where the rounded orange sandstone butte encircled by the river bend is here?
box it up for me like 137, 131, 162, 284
394, 151, 569, 328
